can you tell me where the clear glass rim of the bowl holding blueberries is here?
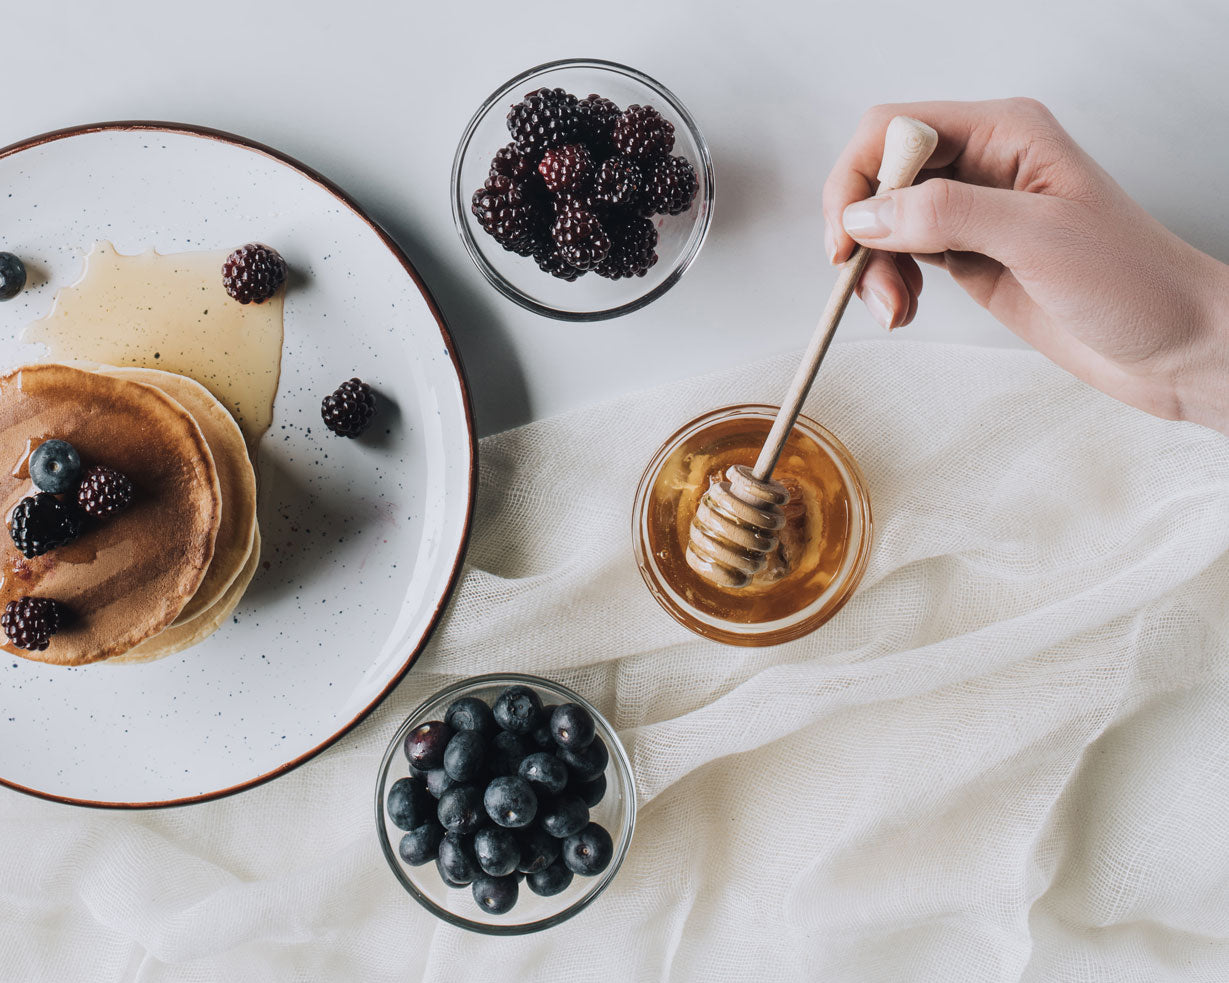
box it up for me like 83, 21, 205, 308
375, 672, 638, 935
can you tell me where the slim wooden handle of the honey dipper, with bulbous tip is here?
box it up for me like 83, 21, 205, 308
752, 116, 939, 480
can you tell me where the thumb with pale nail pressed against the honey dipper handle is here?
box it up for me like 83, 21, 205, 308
842, 178, 1056, 267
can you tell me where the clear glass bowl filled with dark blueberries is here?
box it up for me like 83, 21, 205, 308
376, 673, 635, 935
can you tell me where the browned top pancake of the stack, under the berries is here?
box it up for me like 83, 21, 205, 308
0, 362, 221, 666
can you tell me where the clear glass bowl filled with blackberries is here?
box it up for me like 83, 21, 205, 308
452, 60, 715, 321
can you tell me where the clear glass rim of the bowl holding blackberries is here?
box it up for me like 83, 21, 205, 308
450, 58, 717, 322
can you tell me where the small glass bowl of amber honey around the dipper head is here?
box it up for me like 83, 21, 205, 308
634, 407, 870, 645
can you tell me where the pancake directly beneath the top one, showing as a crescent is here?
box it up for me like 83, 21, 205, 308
100, 367, 256, 624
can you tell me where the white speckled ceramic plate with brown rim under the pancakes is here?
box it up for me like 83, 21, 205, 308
0, 123, 476, 806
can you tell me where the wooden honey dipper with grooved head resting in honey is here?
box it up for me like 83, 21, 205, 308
687, 116, 939, 587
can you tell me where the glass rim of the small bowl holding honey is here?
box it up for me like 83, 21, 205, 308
632, 403, 875, 648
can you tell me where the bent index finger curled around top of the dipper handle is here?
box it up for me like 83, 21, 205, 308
823, 100, 1048, 263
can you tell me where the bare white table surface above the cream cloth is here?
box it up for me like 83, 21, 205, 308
0, 0, 1229, 435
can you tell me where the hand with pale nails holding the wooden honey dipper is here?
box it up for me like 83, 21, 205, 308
823, 100, 1229, 433
